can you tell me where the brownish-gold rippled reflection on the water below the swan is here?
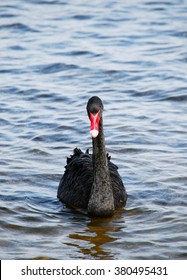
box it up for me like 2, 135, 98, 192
65, 211, 122, 259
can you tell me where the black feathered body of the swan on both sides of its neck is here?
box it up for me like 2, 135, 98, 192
57, 148, 127, 209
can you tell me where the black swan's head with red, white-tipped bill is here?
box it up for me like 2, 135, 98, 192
87, 96, 103, 138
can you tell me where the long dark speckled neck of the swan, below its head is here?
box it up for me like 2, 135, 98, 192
88, 118, 114, 216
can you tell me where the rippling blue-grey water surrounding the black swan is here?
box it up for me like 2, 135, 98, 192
0, 0, 187, 259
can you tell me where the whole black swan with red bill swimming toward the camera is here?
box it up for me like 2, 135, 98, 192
57, 96, 127, 217
